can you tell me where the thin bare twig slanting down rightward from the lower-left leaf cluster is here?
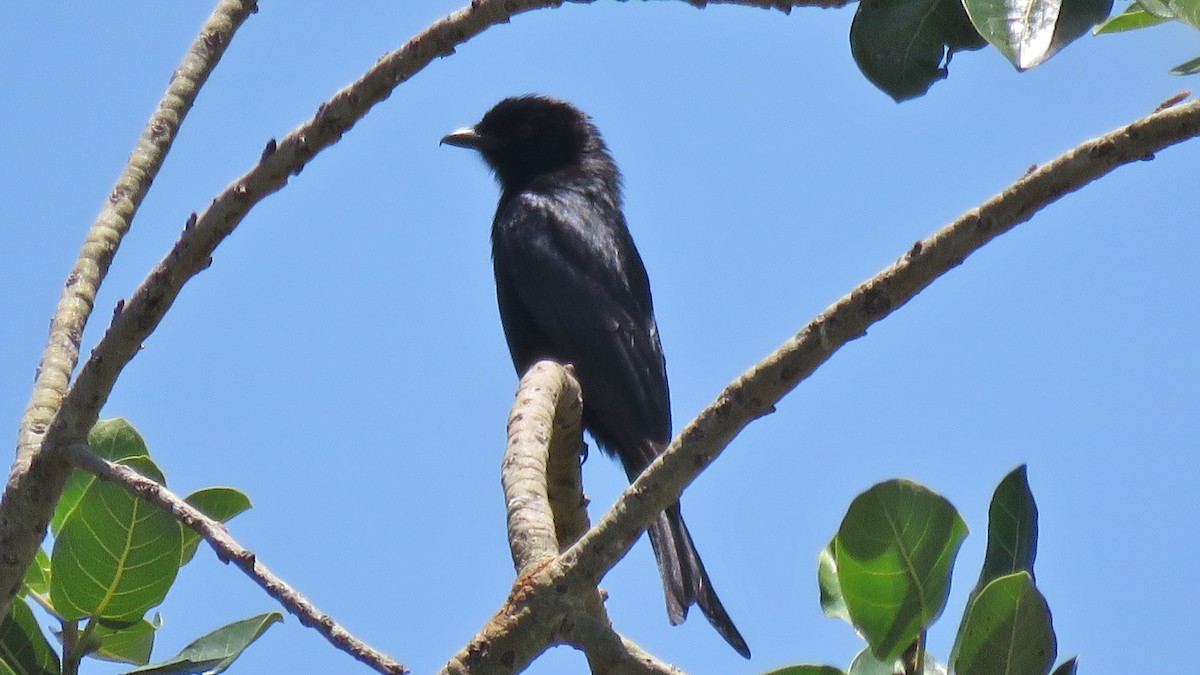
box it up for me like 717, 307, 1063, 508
67, 443, 408, 675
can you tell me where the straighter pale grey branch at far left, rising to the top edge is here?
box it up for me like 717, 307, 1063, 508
0, 0, 256, 615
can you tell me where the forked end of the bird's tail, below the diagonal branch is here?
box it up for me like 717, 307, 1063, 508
647, 502, 750, 658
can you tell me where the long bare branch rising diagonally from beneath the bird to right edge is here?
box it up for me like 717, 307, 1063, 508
562, 94, 1200, 588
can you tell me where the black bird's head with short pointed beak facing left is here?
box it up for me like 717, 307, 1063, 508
442, 95, 604, 190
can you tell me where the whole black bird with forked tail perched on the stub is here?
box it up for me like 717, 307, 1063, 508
442, 95, 750, 658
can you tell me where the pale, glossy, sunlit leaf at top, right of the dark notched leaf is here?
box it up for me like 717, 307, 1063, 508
962, 0, 1112, 71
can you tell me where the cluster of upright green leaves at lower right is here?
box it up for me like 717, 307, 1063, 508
770, 466, 1076, 675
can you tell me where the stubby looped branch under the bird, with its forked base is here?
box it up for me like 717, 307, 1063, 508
442, 362, 679, 675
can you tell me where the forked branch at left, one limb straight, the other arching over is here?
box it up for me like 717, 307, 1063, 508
0, 0, 864, 648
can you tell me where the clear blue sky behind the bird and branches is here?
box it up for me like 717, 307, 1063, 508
0, 5, 1200, 674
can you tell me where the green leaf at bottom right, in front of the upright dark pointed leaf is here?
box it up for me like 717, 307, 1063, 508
952, 572, 1057, 675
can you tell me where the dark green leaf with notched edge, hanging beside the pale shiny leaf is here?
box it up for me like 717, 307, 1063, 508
850, 0, 984, 101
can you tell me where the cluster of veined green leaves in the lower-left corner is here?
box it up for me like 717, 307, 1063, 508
0, 419, 274, 675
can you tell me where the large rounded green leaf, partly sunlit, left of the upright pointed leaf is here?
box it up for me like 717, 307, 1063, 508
834, 480, 967, 662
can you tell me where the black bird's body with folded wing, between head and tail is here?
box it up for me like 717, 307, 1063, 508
492, 186, 671, 454
